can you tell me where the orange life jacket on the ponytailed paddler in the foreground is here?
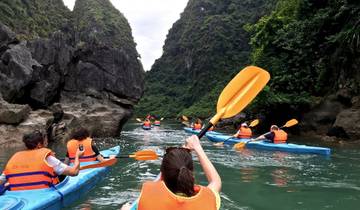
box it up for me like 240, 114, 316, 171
138, 181, 216, 210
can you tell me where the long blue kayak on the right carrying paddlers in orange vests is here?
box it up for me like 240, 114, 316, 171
206, 133, 331, 155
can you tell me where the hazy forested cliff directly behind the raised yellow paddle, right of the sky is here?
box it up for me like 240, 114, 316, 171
135, 0, 273, 117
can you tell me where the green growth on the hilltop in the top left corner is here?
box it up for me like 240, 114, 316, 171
0, 0, 71, 39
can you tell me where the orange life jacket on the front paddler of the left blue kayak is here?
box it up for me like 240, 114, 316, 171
66, 138, 97, 162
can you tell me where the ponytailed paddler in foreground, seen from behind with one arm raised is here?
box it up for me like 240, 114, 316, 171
122, 136, 221, 210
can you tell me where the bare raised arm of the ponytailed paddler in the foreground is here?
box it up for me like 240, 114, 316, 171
185, 135, 221, 192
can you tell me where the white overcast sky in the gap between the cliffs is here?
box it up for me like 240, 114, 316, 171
63, 0, 188, 71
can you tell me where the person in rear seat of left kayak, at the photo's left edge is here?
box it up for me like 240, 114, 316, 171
0, 131, 84, 191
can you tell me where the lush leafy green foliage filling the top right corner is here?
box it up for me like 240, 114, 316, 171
246, 0, 360, 102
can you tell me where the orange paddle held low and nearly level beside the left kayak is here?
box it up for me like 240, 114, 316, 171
80, 150, 158, 170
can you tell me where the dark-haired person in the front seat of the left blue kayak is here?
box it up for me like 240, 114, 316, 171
64, 128, 105, 164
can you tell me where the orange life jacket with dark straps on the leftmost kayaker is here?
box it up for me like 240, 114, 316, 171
4, 148, 59, 191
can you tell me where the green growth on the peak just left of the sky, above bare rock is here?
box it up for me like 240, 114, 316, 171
73, 0, 138, 56
